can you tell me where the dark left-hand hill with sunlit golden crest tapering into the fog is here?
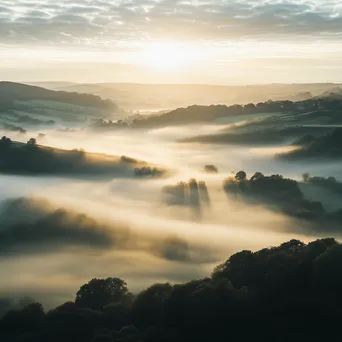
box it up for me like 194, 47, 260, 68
0, 137, 166, 178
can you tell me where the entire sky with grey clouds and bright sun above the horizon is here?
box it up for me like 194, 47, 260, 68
0, 0, 342, 84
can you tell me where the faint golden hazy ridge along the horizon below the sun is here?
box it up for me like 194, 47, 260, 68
31, 82, 341, 111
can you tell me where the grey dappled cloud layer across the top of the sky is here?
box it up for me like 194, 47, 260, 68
0, 0, 342, 46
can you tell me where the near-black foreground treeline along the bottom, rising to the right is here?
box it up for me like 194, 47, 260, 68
0, 238, 342, 342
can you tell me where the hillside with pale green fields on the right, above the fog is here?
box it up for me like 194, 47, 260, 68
179, 98, 342, 145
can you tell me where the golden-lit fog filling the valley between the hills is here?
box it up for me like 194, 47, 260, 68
0, 121, 340, 307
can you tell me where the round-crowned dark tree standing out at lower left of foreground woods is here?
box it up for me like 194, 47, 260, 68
75, 278, 128, 310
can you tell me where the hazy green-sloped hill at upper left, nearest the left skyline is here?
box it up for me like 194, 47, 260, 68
0, 82, 125, 132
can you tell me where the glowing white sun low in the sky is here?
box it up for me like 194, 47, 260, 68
140, 43, 193, 71
